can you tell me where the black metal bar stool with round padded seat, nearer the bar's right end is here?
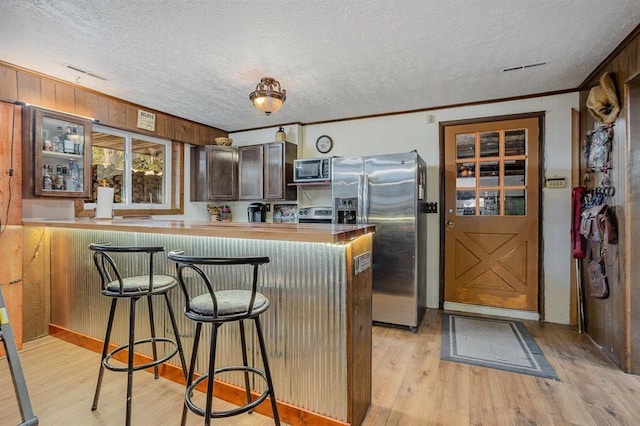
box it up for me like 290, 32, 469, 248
168, 251, 280, 426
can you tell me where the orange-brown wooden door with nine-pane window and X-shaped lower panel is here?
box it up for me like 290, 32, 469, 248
444, 117, 540, 312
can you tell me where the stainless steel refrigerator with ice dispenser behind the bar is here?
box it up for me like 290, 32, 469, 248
331, 151, 426, 331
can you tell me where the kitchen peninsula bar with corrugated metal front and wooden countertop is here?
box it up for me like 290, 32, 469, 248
23, 219, 375, 425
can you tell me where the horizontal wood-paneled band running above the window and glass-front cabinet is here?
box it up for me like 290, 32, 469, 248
0, 61, 227, 145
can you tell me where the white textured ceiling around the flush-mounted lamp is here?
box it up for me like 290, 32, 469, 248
0, 0, 640, 131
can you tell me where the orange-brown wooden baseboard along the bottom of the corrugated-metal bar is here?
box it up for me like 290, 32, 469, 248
49, 324, 349, 426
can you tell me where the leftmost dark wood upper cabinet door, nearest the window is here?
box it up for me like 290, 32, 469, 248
207, 146, 238, 200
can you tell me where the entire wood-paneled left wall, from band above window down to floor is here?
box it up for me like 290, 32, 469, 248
0, 61, 227, 347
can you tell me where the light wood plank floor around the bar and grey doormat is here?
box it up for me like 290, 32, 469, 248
0, 310, 640, 426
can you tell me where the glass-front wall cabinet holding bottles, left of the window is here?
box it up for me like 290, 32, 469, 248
23, 106, 93, 199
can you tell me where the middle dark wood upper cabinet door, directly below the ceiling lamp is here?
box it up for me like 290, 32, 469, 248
238, 145, 264, 200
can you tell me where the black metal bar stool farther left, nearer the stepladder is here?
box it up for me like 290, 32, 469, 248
89, 243, 187, 425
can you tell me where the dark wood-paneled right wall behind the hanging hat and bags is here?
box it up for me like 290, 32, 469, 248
579, 27, 640, 374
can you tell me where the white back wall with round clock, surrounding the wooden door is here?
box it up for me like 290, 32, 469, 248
230, 92, 579, 324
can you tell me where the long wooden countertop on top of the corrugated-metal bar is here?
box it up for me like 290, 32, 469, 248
22, 218, 375, 243
